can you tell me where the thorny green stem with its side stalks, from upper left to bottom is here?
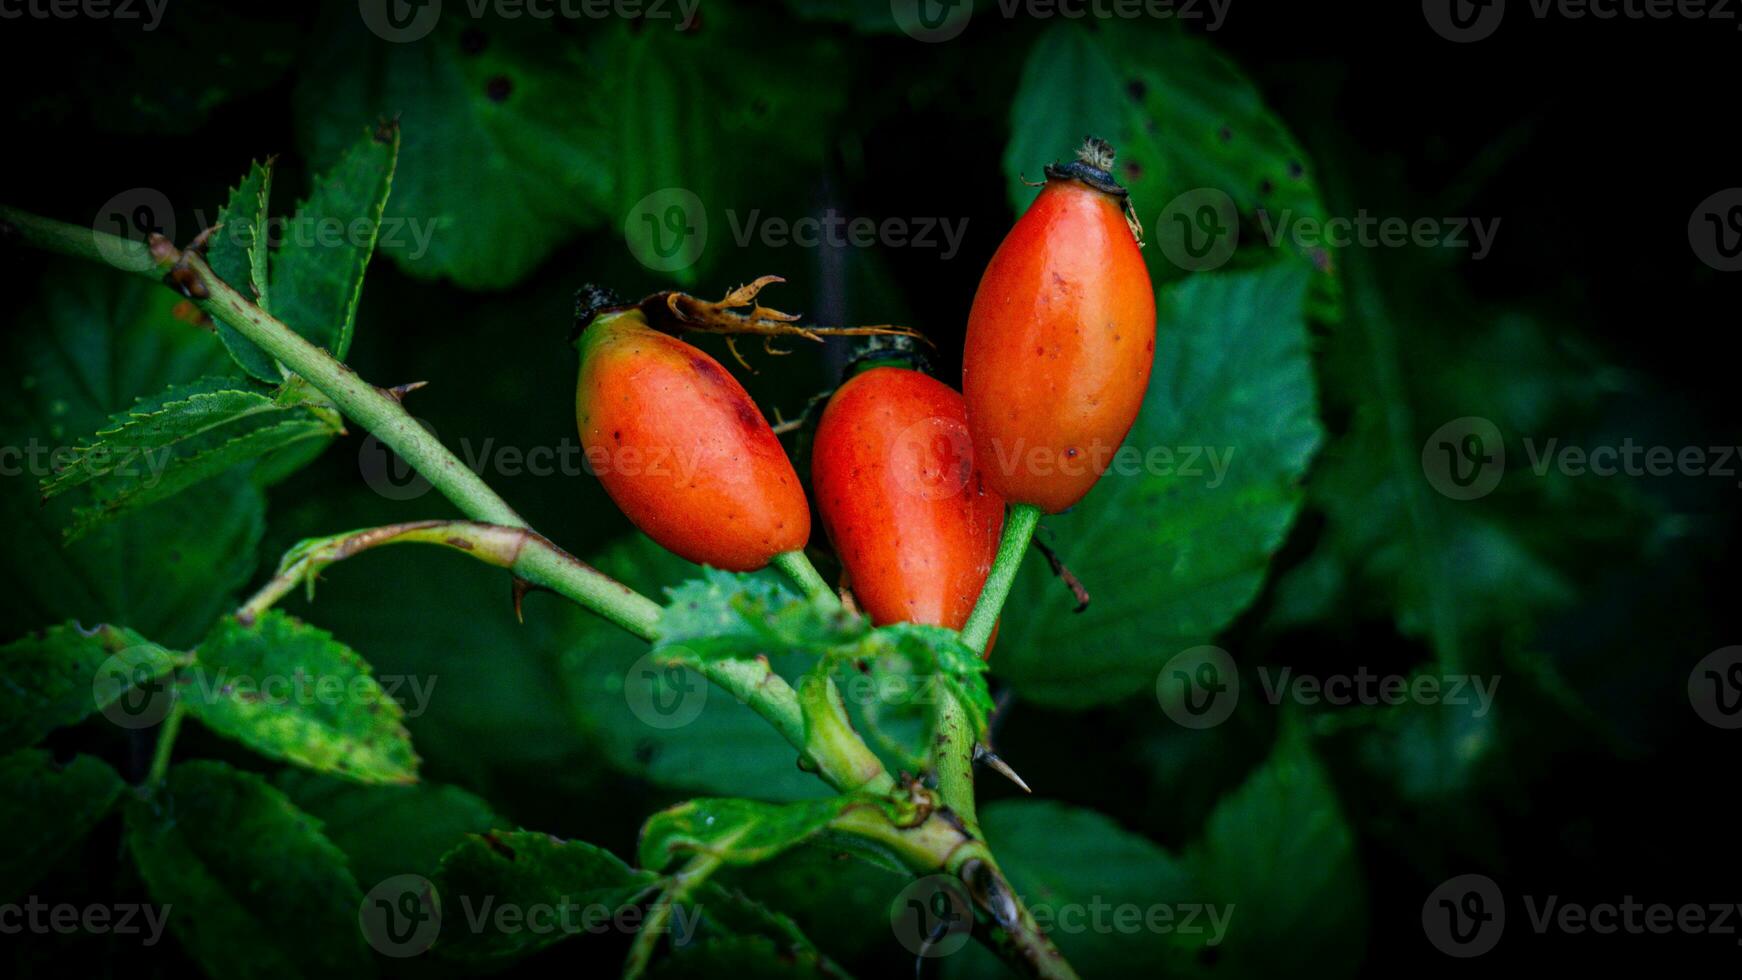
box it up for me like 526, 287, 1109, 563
0, 205, 1075, 980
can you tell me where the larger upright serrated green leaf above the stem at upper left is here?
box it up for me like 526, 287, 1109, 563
268, 124, 399, 360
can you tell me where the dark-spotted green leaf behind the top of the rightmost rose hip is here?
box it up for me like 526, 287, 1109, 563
1003, 21, 1338, 309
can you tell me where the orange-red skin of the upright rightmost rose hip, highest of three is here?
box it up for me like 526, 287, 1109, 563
962, 178, 1155, 513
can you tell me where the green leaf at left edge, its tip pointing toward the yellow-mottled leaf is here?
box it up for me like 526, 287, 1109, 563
0, 623, 185, 752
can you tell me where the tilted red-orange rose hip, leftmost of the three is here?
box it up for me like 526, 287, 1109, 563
575, 310, 810, 571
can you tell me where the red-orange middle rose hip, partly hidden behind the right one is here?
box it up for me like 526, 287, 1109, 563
810, 367, 1003, 630
